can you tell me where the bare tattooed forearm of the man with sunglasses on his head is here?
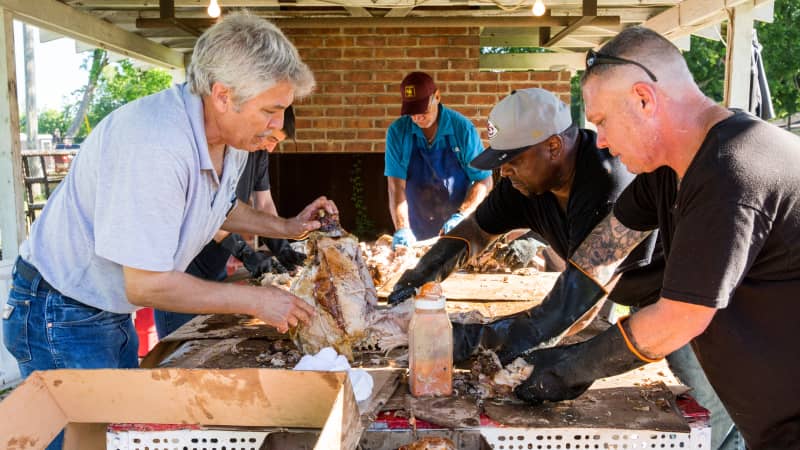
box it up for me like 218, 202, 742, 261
572, 214, 651, 285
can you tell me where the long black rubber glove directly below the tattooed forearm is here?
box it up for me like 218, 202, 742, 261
453, 264, 605, 365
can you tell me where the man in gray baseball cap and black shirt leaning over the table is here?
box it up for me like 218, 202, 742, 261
389, 89, 738, 450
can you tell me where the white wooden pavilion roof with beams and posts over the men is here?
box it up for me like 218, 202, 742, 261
0, 0, 774, 263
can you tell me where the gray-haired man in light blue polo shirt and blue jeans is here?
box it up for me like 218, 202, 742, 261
3, 14, 328, 446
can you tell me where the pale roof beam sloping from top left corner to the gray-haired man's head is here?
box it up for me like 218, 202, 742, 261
0, 0, 184, 69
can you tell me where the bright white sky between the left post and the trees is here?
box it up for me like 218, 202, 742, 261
14, 21, 91, 114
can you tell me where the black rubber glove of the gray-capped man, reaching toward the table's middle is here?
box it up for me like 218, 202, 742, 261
387, 236, 469, 305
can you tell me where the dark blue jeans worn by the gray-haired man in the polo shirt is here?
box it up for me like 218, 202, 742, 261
3, 258, 139, 449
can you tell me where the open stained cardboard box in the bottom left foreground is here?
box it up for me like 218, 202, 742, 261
0, 369, 360, 450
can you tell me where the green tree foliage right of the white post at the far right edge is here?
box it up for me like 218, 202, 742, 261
756, 0, 800, 124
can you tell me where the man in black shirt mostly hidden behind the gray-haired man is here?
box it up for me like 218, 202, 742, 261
154, 106, 305, 339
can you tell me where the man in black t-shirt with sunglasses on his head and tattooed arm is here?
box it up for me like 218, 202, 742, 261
515, 27, 800, 449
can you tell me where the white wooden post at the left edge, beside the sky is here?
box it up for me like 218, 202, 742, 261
0, 8, 26, 260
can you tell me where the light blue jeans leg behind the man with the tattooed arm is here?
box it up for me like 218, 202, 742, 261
667, 344, 745, 450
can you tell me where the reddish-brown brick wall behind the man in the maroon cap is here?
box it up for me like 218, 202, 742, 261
279, 27, 570, 153
